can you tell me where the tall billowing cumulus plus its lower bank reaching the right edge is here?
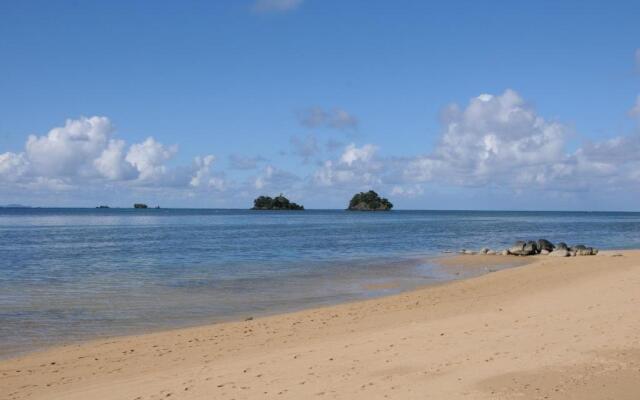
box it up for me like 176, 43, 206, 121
401, 90, 640, 192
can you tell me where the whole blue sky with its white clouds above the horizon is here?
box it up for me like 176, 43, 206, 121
0, 0, 640, 210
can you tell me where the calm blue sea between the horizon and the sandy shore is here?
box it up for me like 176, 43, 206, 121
0, 209, 640, 356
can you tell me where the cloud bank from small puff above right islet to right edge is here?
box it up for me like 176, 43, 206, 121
313, 90, 640, 197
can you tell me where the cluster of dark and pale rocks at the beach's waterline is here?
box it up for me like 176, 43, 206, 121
460, 239, 598, 257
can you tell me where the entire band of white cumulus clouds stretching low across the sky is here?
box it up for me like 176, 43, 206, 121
7, 90, 640, 206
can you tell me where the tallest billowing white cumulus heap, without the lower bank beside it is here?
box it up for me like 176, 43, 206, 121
404, 90, 567, 185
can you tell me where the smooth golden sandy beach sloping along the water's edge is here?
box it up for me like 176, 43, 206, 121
0, 251, 640, 400
